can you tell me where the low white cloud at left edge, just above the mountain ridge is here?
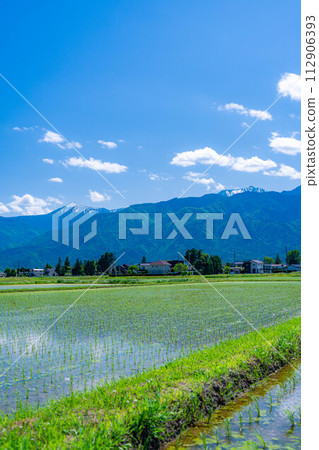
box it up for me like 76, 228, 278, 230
0, 194, 62, 216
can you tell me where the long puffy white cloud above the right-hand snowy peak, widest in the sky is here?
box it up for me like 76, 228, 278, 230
171, 147, 277, 172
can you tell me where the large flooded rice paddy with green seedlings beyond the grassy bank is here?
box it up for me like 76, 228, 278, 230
0, 280, 300, 413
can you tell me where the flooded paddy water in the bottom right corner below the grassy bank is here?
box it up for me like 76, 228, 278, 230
166, 361, 301, 450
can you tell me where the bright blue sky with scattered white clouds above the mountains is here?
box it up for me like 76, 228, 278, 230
0, 0, 300, 216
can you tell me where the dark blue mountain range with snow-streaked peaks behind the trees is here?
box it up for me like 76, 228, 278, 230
0, 186, 301, 270
